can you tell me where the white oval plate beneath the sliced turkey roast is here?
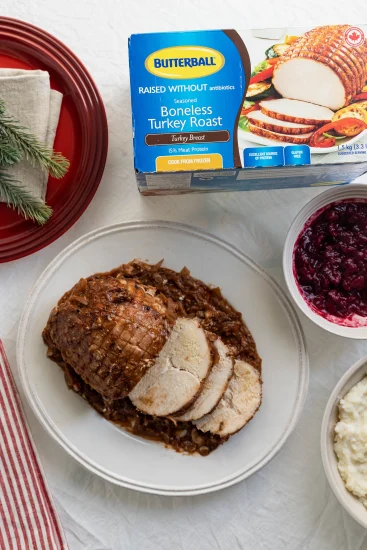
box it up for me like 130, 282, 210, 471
17, 222, 308, 495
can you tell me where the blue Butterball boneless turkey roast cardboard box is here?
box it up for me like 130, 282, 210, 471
129, 25, 367, 194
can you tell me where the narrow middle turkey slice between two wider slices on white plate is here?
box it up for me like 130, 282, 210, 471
175, 338, 233, 421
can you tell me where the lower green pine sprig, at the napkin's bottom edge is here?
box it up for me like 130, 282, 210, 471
0, 168, 52, 225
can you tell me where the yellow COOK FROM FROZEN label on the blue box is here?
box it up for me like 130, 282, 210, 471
156, 153, 223, 172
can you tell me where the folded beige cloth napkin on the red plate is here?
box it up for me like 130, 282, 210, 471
0, 69, 62, 200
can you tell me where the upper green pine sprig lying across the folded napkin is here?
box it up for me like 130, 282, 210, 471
0, 100, 70, 179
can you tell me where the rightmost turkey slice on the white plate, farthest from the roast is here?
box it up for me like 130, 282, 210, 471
194, 360, 262, 437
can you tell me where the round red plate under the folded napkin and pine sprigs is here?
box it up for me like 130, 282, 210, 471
0, 17, 108, 262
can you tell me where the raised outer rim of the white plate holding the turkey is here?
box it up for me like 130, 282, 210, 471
16, 220, 309, 496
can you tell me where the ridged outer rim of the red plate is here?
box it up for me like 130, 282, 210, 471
0, 16, 108, 263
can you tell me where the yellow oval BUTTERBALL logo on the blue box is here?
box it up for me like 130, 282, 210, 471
145, 46, 225, 79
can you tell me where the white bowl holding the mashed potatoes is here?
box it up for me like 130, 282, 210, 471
321, 356, 367, 529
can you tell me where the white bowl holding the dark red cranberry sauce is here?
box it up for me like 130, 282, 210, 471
283, 183, 367, 339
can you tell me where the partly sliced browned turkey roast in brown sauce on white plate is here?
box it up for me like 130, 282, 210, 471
43, 260, 262, 455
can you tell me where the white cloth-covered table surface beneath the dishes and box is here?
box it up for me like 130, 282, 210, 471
0, 0, 367, 550
